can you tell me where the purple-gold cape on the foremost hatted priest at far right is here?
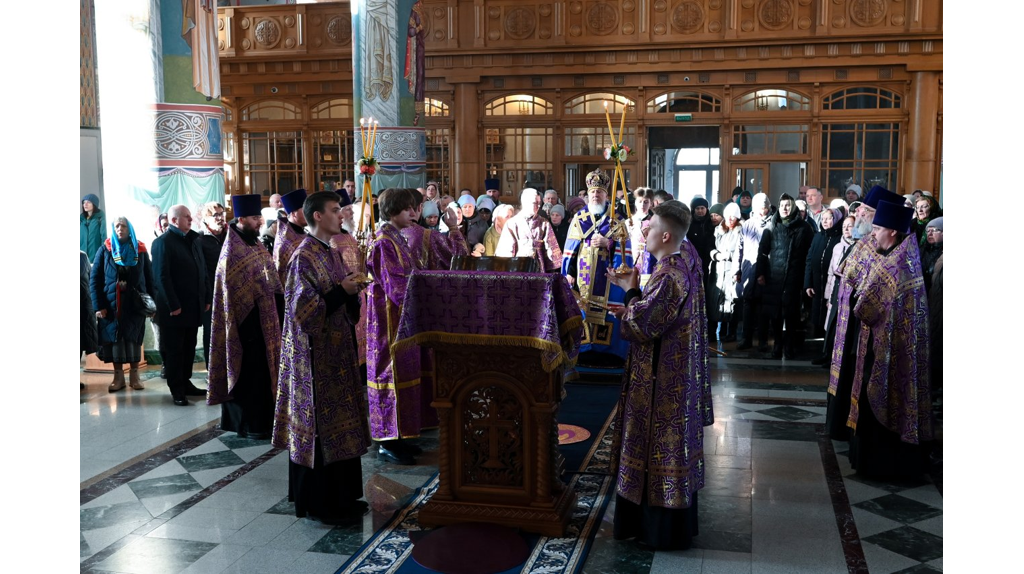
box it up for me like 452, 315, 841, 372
847, 233, 932, 444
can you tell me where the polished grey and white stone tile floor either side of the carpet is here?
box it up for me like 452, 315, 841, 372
80, 344, 942, 573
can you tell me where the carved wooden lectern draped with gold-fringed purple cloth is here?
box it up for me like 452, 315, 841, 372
395, 271, 583, 537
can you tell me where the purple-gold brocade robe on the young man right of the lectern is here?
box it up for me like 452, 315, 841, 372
613, 248, 715, 509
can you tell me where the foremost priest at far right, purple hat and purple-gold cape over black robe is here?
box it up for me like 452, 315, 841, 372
847, 202, 932, 479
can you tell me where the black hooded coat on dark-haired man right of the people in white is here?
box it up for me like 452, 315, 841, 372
758, 213, 811, 315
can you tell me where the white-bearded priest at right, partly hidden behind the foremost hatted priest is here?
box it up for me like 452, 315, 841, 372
825, 185, 903, 440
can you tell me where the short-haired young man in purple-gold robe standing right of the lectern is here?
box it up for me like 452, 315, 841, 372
608, 201, 715, 549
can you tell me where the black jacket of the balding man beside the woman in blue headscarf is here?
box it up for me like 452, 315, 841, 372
153, 225, 213, 328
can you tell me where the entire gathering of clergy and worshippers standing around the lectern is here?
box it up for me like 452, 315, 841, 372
81, 170, 942, 548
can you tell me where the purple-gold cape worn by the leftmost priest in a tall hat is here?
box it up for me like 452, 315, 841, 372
206, 225, 282, 404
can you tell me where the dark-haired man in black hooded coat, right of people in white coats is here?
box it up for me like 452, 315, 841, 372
758, 193, 812, 359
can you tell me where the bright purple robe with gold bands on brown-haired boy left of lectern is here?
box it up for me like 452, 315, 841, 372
367, 223, 437, 440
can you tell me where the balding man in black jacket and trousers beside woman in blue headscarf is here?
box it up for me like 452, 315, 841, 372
153, 205, 213, 406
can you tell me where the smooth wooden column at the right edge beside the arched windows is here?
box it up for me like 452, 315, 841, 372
903, 72, 939, 193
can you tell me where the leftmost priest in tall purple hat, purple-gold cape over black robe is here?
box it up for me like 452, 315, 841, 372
206, 194, 285, 439
